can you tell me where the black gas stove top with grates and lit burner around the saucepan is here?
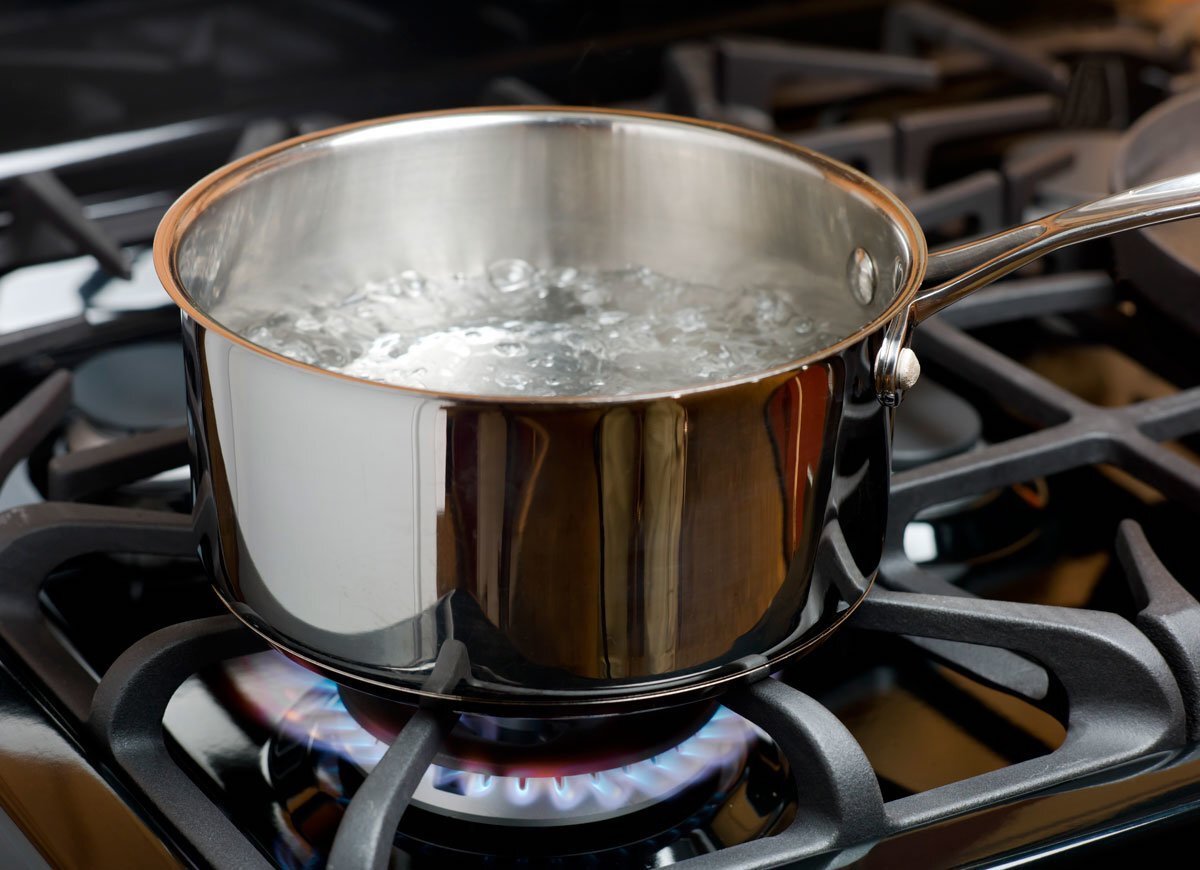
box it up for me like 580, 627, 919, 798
0, 0, 1200, 868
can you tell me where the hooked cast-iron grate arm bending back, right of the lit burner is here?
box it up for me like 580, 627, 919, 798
853, 589, 1187, 830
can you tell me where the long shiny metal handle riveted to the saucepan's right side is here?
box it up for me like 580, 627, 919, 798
875, 173, 1200, 406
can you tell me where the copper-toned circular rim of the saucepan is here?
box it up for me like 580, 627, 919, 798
154, 106, 928, 407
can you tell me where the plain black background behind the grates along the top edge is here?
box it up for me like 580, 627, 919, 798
0, 0, 1112, 150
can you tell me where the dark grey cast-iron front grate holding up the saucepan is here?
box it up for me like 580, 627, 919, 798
0, 261, 1200, 866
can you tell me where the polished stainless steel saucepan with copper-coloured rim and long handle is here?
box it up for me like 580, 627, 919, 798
155, 108, 1200, 716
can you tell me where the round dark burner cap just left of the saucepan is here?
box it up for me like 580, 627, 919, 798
74, 342, 187, 432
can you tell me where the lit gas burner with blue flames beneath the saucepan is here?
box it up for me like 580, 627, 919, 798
217, 652, 796, 866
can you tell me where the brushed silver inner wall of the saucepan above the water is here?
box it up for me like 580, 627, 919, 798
176, 110, 911, 360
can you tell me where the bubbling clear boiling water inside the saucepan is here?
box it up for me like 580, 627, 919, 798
220, 259, 863, 396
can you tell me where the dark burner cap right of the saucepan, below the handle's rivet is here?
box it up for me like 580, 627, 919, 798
892, 378, 983, 472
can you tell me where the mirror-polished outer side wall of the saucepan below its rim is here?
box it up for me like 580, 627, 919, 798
186, 320, 887, 704
